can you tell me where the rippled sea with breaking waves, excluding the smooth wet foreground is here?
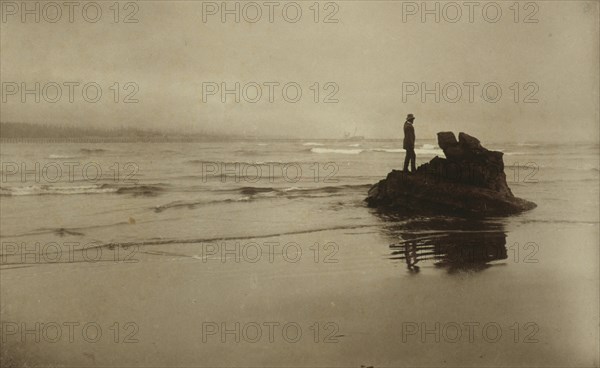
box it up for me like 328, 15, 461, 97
0, 141, 599, 243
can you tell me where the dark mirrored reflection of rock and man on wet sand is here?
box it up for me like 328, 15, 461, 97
390, 219, 508, 272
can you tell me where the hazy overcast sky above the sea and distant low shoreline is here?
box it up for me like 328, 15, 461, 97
0, 1, 599, 142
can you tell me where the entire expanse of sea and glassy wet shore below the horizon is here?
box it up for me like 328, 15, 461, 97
0, 140, 600, 366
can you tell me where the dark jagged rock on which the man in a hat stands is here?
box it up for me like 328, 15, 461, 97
366, 132, 536, 215
